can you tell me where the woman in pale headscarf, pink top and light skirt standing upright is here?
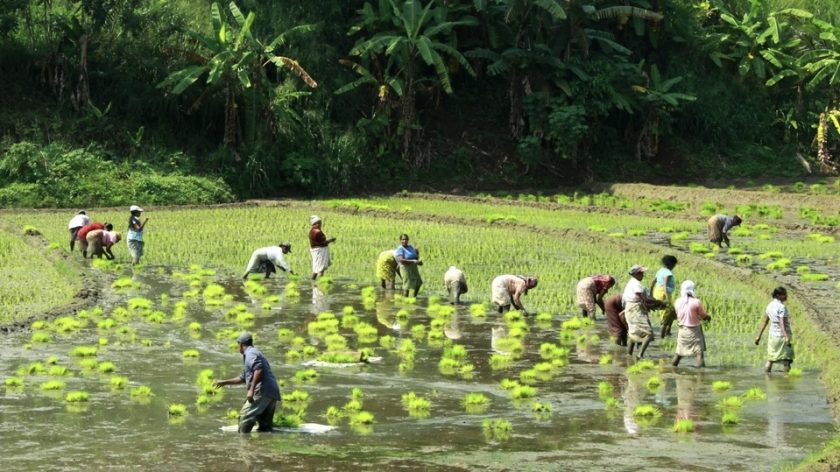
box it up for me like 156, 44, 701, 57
671, 280, 712, 367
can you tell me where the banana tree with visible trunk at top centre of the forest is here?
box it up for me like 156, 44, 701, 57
349, 0, 477, 165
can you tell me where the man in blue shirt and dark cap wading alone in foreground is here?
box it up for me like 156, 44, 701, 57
213, 333, 280, 433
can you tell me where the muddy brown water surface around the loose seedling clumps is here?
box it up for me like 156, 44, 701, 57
0, 271, 834, 470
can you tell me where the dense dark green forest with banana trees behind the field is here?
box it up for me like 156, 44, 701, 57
0, 0, 840, 201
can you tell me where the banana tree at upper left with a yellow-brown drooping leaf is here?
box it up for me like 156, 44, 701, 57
158, 2, 318, 147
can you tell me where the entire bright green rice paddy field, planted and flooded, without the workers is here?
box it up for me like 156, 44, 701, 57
0, 187, 840, 470
